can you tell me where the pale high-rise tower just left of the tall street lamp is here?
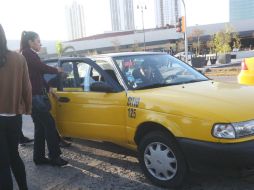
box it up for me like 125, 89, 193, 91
110, 0, 135, 31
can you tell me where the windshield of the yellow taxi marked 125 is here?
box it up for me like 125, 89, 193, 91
113, 54, 209, 89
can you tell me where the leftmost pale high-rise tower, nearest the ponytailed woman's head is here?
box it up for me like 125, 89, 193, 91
65, 1, 86, 40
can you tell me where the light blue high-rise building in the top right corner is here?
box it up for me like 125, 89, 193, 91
229, 0, 254, 22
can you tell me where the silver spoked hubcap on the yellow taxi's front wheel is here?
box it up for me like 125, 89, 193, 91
144, 142, 177, 181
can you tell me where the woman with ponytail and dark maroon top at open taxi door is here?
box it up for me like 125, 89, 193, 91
20, 31, 68, 166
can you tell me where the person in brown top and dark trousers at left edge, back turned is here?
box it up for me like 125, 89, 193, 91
0, 25, 32, 190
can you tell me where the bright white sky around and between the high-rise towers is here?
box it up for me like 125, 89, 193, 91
0, 0, 229, 41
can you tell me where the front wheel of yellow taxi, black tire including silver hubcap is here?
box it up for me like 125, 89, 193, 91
138, 131, 188, 188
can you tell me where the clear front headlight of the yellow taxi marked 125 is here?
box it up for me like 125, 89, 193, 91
212, 120, 254, 139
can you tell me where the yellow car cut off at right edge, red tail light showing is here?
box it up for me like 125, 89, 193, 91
238, 57, 254, 85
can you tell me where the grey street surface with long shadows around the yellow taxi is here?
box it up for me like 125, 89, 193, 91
15, 77, 254, 190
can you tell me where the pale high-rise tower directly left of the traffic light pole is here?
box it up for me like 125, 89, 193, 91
154, 0, 181, 28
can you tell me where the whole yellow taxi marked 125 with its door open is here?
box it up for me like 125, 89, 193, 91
43, 52, 254, 187
